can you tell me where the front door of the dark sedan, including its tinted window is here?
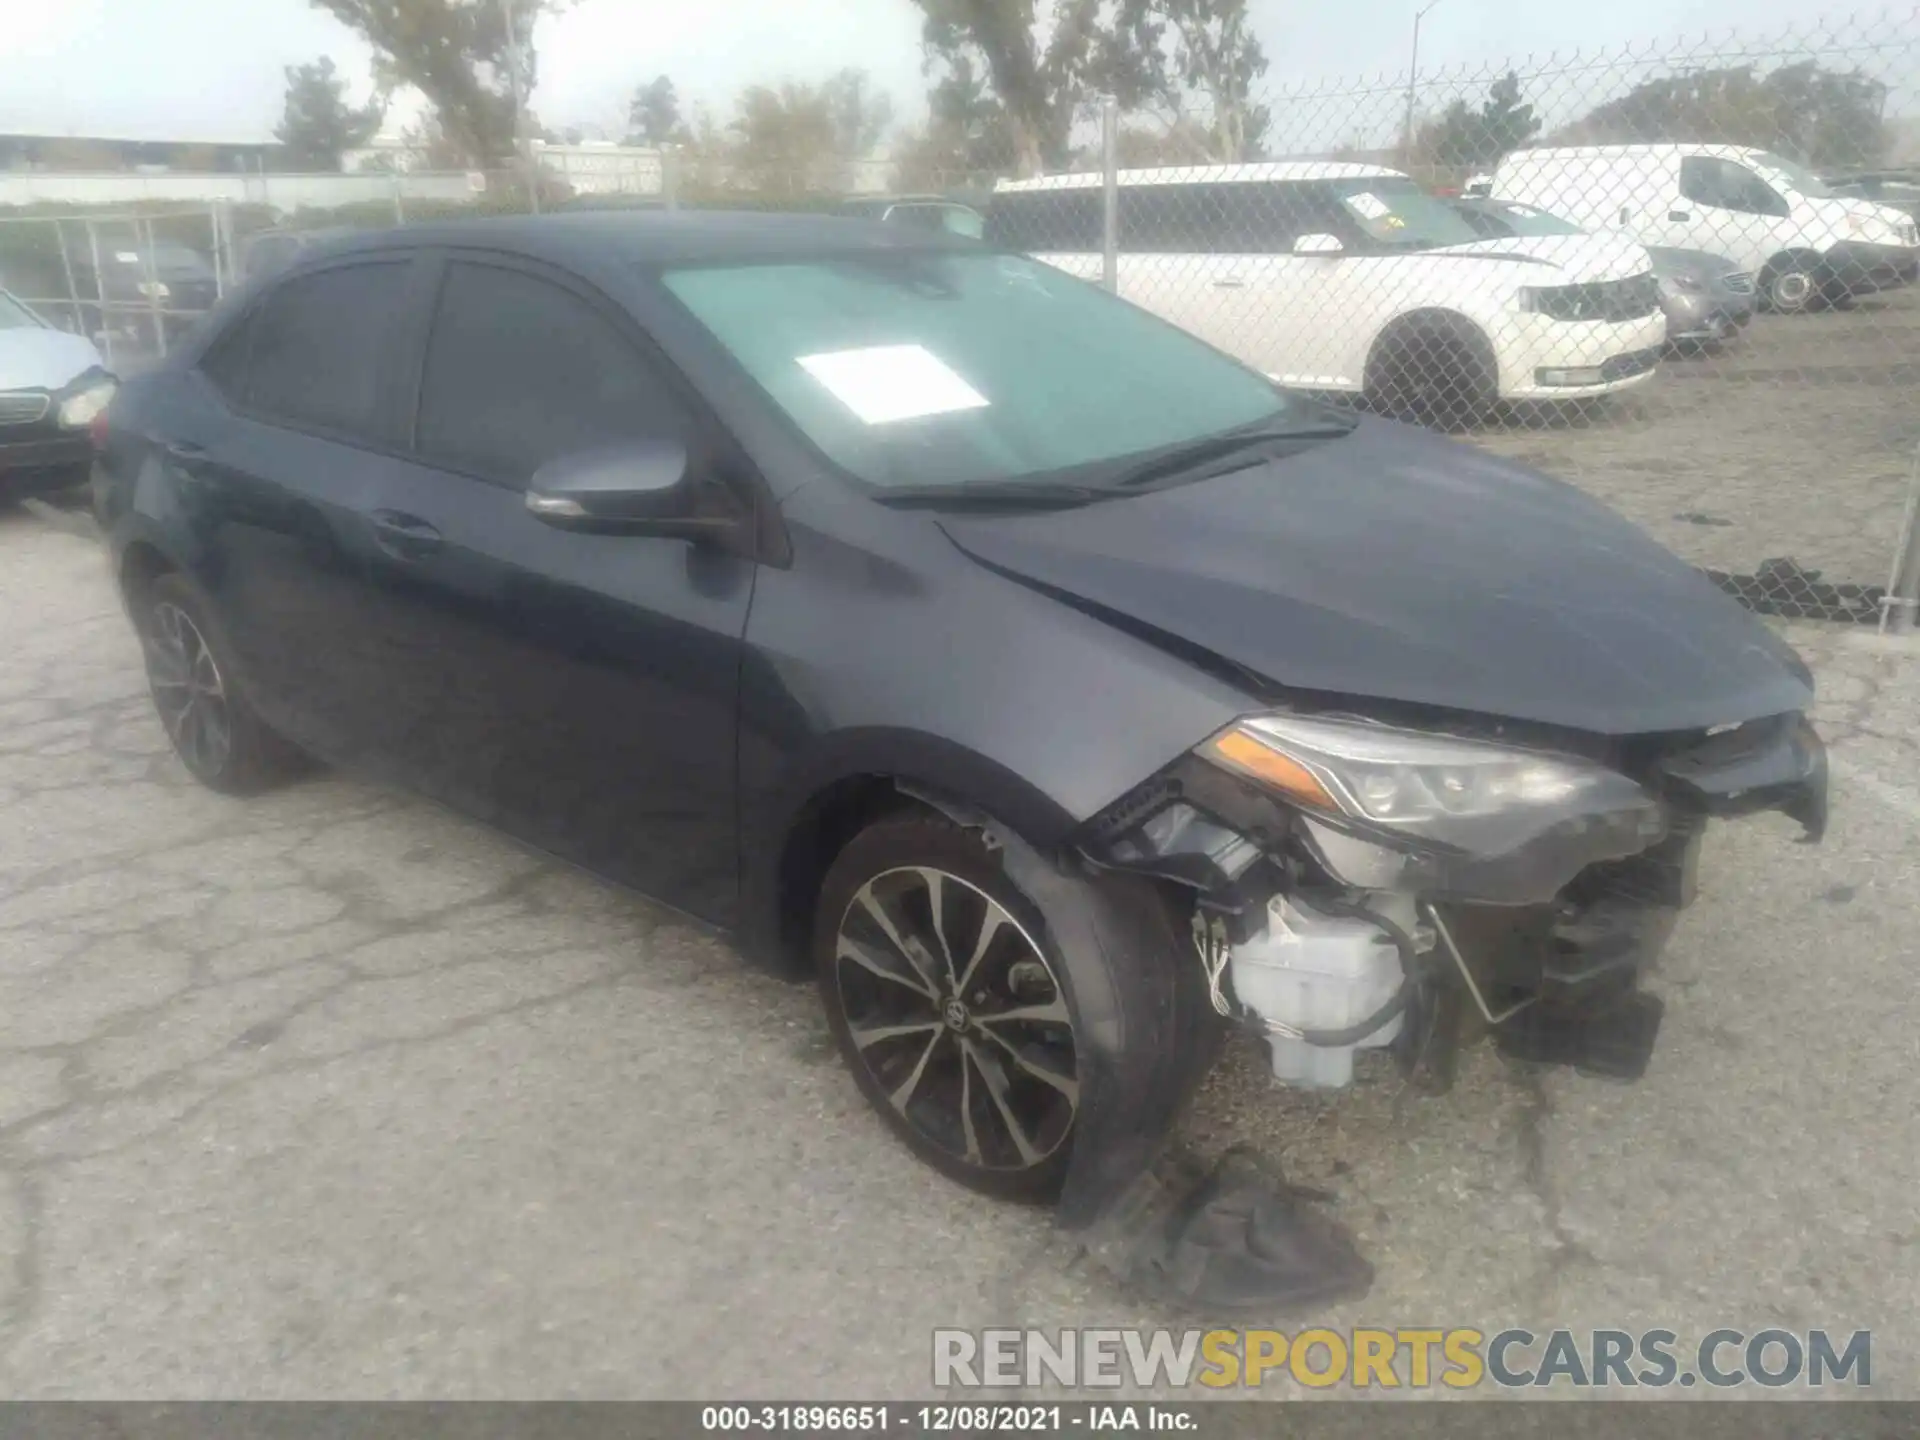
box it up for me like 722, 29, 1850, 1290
353, 252, 758, 922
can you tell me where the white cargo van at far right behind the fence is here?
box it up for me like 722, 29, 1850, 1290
1494, 144, 1920, 311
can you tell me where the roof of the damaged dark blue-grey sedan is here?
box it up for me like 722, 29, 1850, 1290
289, 209, 966, 265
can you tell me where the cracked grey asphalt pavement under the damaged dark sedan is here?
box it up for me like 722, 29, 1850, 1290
0, 511, 1920, 1400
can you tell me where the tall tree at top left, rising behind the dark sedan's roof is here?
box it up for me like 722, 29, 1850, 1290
311, 0, 568, 165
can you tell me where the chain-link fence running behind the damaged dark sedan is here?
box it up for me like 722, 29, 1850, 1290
0, 12, 1920, 628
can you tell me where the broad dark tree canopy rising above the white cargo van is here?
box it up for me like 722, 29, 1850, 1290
1555, 60, 1887, 167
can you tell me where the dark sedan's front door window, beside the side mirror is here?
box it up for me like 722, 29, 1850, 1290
417, 261, 693, 486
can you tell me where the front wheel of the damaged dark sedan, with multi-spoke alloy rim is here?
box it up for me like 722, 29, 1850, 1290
812, 812, 1081, 1202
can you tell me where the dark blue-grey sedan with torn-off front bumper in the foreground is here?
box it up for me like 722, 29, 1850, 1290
94, 213, 1826, 1304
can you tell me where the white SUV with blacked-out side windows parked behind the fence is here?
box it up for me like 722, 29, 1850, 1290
987, 163, 1667, 420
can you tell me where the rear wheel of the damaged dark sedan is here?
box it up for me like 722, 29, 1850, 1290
134, 574, 303, 795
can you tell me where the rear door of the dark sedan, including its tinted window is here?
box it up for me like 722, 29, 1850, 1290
152, 252, 415, 764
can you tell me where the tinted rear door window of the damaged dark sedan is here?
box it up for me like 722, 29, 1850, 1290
242, 259, 407, 440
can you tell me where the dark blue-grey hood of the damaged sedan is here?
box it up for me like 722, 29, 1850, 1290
939, 420, 1812, 735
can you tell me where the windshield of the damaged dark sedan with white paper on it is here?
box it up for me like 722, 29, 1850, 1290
662, 252, 1292, 488
